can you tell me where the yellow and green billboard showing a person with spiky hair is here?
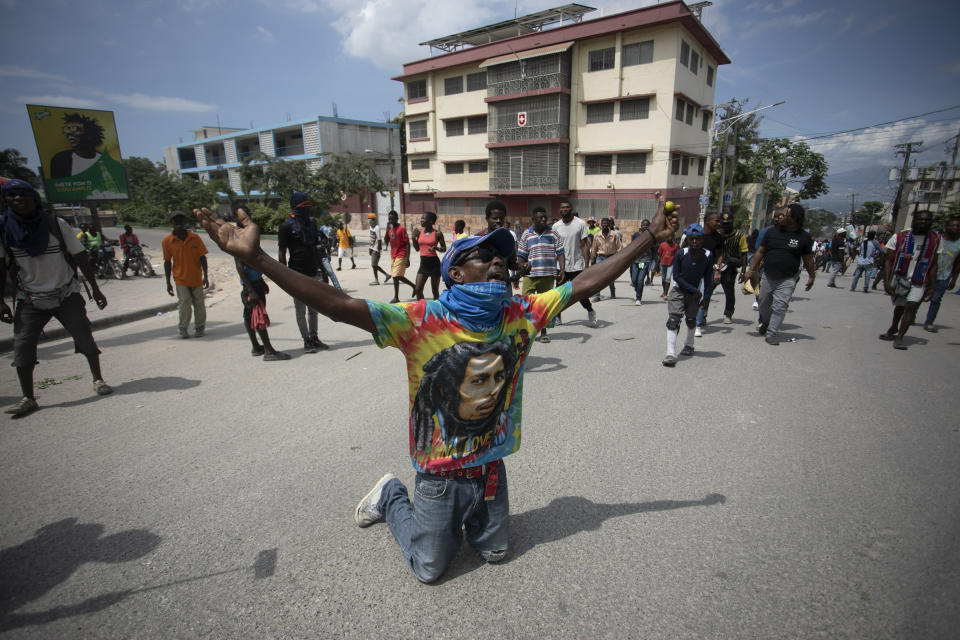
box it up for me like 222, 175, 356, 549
27, 104, 130, 202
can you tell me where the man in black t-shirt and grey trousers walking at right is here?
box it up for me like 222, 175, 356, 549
740, 204, 816, 346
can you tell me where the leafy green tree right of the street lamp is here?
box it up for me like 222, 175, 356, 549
750, 138, 830, 206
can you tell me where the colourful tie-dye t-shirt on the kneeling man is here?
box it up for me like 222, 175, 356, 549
367, 283, 572, 473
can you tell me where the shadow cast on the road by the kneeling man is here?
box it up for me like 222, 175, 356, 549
433, 493, 727, 585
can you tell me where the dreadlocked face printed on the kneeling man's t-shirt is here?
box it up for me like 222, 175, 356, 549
412, 342, 515, 457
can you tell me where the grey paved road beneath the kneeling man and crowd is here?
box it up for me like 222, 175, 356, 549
0, 251, 960, 639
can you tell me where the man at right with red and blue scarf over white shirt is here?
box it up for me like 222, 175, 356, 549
880, 210, 940, 350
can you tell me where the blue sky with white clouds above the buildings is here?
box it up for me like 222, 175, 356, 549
0, 0, 960, 208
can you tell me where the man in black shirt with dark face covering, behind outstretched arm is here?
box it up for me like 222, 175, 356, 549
277, 191, 330, 353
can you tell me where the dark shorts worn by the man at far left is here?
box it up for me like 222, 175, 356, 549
13, 293, 100, 367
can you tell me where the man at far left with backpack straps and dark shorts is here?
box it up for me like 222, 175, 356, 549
0, 180, 113, 417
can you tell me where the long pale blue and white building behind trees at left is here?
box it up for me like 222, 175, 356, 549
163, 116, 401, 219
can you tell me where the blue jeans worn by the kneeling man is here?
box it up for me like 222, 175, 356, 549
377, 460, 510, 582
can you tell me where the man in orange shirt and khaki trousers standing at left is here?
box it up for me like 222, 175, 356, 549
162, 211, 210, 338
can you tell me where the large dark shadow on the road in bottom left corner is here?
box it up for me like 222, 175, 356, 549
0, 518, 162, 632
